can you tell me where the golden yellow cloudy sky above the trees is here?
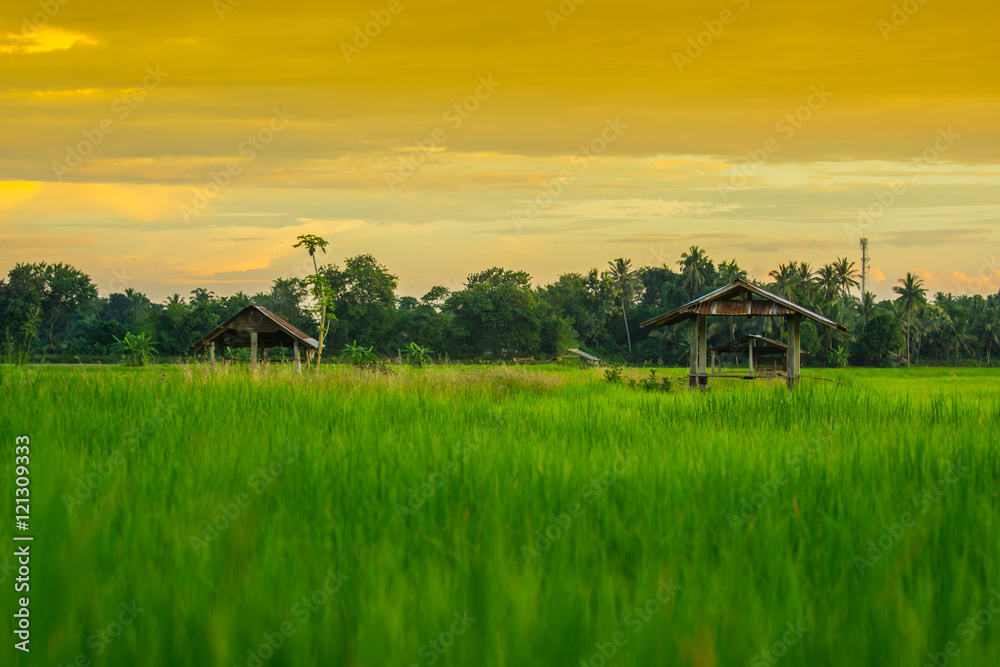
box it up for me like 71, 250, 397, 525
0, 0, 1000, 300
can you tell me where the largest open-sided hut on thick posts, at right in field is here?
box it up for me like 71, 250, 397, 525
641, 280, 847, 389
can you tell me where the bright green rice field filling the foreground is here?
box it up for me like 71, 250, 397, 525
0, 366, 1000, 667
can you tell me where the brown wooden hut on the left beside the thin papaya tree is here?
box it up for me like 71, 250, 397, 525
191, 306, 319, 372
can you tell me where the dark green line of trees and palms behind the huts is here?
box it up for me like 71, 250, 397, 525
0, 246, 1000, 366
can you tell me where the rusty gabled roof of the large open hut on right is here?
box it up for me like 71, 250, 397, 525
640, 280, 847, 331
